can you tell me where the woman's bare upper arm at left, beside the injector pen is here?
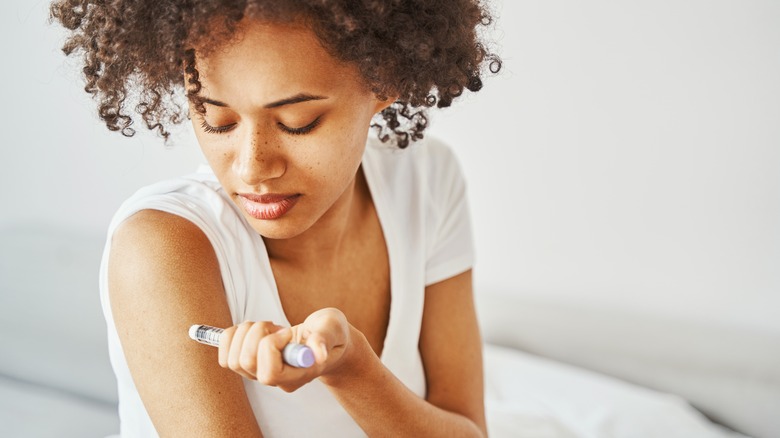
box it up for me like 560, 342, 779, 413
108, 210, 260, 437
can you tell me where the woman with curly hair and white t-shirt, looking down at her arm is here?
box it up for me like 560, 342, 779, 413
52, 0, 498, 437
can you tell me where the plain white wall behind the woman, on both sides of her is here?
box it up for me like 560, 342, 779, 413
0, 0, 780, 331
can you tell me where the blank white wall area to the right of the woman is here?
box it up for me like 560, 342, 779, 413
426, 0, 780, 331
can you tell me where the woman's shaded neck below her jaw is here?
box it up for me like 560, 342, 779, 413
263, 168, 371, 268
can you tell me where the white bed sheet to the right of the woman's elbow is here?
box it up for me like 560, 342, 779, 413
485, 344, 746, 438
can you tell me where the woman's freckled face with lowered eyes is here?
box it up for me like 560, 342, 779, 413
191, 20, 390, 239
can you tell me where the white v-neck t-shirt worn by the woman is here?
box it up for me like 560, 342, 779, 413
100, 139, 474, 437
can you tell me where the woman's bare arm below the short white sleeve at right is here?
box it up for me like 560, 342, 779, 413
420, 270, 486, 433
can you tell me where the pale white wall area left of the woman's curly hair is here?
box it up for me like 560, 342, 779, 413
0, 0, 201, 233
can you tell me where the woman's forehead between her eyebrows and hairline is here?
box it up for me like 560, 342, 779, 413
197, 19, 366, 106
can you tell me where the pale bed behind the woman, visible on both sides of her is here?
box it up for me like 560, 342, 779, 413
0, 224, 780, 438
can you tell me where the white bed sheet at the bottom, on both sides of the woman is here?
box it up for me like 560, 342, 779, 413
0, 345, 746, 438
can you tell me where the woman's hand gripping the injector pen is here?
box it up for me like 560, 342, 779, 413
219, 308, 351, 392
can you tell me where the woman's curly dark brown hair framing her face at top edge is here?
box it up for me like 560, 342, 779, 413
50, 0, 501, 148
